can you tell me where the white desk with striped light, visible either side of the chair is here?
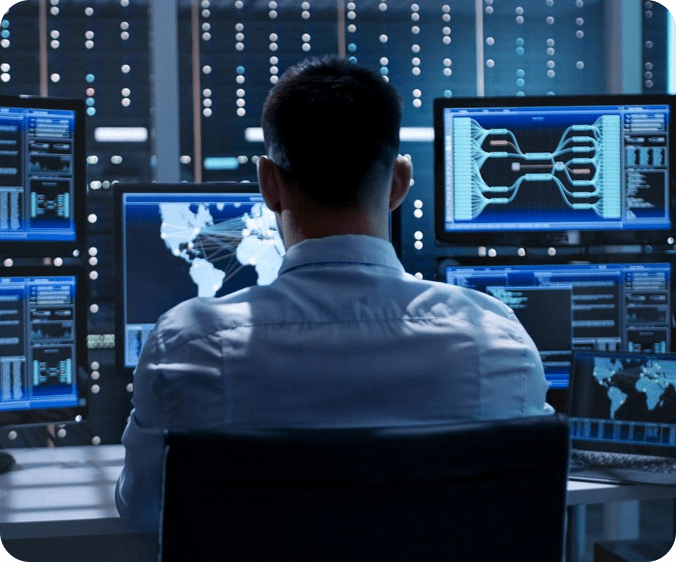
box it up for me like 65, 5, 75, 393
0, 445, 676, 562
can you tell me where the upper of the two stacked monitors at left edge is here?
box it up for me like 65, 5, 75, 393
0, 96, 86, 257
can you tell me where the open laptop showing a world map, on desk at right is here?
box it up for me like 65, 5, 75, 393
568, 351, 676, 485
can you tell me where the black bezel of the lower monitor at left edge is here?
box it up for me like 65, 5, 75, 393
0, 265, 90, 426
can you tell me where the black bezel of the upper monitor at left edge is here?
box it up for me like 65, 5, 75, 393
0, 95, 87, 259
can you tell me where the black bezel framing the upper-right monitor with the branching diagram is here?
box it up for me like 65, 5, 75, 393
433, 94, 676, 248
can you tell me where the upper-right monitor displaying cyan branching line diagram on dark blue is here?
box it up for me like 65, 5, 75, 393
434, 94, 676, 247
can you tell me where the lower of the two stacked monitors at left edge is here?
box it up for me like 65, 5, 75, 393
0, 267, 88, 426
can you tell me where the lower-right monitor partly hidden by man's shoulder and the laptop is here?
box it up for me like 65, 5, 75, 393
442, 255, 674, 388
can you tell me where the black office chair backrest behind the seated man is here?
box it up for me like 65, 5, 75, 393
160, 414, 568, 562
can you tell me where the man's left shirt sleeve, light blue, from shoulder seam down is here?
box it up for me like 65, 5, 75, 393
115, 302, 226, 531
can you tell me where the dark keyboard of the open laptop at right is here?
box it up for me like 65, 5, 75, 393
569, 449, 676, 486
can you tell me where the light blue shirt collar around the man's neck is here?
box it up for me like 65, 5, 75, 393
279, 234, 404, 275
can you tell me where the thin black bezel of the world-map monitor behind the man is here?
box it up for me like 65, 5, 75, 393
113, 181, 260, 376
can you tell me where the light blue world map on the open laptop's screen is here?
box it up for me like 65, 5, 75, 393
593, 357, 676, 419
